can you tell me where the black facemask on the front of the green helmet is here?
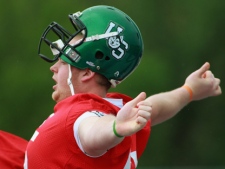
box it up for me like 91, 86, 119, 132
38, 12, 87, 62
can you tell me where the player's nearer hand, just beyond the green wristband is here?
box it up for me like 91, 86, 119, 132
116, 92, 152, 136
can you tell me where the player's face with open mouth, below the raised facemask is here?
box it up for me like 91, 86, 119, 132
50, 59, 80, 102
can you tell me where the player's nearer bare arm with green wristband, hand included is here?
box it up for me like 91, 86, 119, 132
79, 92, 152, 156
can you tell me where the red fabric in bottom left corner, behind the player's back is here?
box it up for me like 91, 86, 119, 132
0, 130, 28, 169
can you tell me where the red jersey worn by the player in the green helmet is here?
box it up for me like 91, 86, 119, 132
24, 94, 150, 169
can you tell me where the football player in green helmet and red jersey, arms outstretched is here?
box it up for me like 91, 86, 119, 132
21, 5, 221, 169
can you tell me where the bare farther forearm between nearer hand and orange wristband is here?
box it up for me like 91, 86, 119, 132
149, 87, 190, 125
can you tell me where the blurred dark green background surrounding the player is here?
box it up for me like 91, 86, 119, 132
0, 0, 225, 168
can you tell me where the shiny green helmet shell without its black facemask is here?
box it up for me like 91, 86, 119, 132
60, 5, 144, 83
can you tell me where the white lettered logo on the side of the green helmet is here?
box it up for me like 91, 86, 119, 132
105, 22, 129, 59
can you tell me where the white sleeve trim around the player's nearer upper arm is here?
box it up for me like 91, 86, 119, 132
73, 111, 105, 157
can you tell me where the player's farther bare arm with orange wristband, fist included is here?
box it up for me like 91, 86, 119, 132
146, 62, 222, 125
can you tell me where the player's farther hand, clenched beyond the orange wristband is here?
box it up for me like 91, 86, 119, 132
185, 62, 222, 100
